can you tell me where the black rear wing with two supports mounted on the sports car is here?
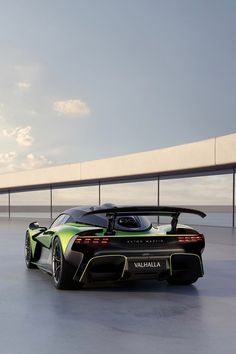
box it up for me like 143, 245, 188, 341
84, 206, 206, 235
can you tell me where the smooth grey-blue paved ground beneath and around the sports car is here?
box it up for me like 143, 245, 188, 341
0, 220, 236, 354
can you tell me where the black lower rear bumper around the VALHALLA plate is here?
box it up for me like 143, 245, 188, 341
74, 253, 204, 283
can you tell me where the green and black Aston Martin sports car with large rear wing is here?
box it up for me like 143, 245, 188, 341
25, 204, 206, 289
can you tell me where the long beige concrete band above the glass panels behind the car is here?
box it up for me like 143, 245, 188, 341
0, 134, 236, 192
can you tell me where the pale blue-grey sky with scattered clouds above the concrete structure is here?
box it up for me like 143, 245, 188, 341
0, 0, 236, 173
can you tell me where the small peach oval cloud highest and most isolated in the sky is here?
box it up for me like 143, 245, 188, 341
53, 100, 90, 117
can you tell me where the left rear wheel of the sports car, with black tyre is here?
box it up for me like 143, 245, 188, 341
52, 237, 75, 289
